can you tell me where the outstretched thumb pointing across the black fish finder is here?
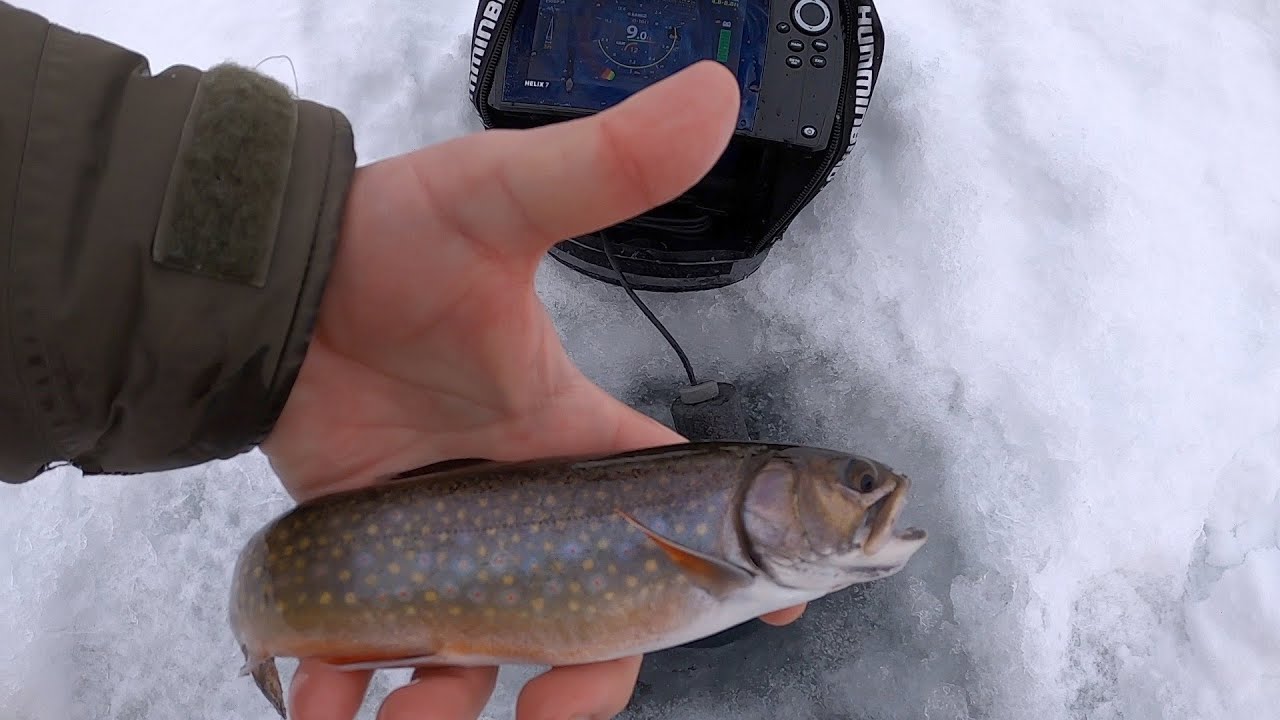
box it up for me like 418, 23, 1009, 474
404, 61, 739, 264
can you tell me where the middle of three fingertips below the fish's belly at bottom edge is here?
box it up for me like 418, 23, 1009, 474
378, 667, 498, 720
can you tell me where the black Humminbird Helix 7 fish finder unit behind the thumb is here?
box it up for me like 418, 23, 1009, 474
470, 0, 883, 292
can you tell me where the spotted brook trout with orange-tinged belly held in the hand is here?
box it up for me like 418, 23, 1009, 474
229, 442, 928, 717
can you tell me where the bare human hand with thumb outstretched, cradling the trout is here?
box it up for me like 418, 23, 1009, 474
262, 63, 803, 720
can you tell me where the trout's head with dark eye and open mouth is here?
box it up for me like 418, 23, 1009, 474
741, 447, 927, 593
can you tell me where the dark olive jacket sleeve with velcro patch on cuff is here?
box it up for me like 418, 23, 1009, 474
0, 1, 356, 483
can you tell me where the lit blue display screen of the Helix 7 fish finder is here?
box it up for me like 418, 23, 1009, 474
503, 0, 769, 129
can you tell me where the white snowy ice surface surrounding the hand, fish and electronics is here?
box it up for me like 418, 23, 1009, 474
0, 0, 1280, 720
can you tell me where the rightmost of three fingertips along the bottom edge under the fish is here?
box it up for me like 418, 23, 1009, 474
516, 656, 644, 720
